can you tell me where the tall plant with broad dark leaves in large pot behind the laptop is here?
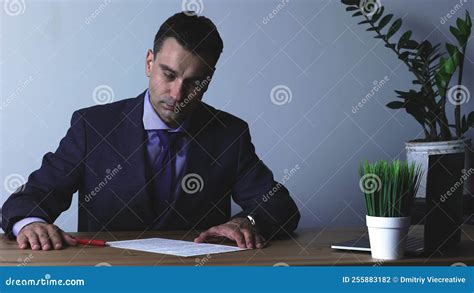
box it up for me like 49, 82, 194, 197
342, 0, 474, 197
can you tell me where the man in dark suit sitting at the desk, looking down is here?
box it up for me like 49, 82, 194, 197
2, 12, 300, 250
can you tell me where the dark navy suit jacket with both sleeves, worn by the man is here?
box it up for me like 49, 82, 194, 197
2, 93, 300, 237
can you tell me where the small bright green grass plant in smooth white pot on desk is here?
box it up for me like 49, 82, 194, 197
359, 160, 423, 260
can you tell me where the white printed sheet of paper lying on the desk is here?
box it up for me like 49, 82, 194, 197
107, 238, 247, 257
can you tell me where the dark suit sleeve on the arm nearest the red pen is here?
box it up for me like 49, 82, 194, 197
2, 111, 85, 238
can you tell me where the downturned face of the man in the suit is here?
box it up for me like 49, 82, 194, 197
146, 38, 213, 128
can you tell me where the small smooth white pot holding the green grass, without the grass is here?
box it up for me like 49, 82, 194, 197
366, 216, 411, 260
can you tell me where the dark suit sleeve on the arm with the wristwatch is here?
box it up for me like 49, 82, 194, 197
232, 123, 300, 239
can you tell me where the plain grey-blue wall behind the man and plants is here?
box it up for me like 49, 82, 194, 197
0, 0, 474, 231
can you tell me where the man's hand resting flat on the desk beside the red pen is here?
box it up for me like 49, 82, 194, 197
16, 222, 77, 250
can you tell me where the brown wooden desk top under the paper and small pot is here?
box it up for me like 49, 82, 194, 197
0, 225, 474, 266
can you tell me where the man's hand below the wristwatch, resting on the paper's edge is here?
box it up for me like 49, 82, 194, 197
194, 218, 265, 249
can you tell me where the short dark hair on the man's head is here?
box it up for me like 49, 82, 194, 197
153, 11, 224, 66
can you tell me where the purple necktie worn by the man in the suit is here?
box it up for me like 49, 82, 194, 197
153, 130, 182, 215
